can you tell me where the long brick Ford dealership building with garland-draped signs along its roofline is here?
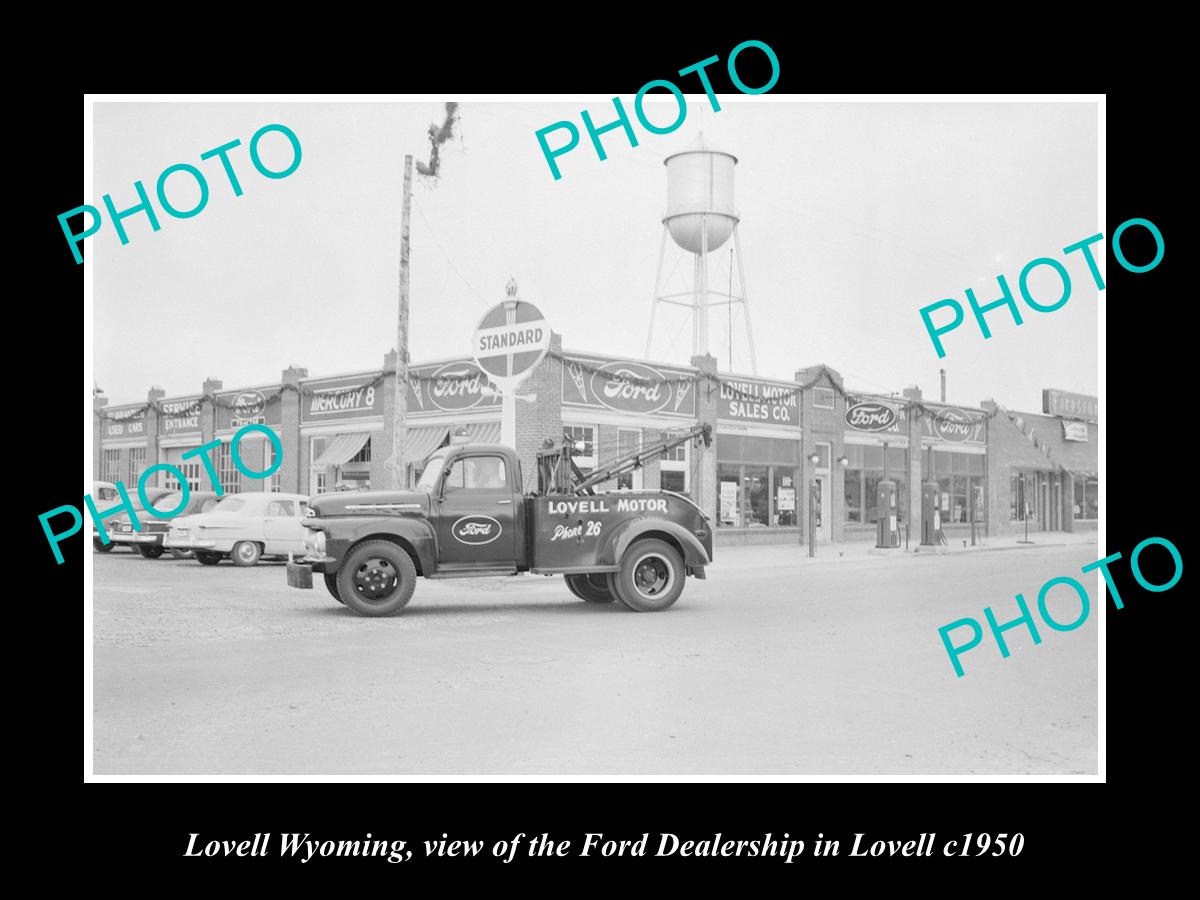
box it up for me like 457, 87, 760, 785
94, 335, 1098, 545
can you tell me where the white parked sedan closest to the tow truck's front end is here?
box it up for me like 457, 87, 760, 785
163, 492, 308, 565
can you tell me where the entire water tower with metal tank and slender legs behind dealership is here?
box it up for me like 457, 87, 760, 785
646, 134, 758, 374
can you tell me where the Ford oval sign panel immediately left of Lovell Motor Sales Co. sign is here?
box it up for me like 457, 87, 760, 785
563, 359, 696, 418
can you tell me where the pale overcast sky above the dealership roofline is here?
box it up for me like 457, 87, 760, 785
93, 95, 1104, 410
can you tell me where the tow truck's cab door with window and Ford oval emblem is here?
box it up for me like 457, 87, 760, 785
434, 454, 521, 566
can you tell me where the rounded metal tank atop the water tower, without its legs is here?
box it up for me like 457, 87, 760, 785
662, 134, 738, 259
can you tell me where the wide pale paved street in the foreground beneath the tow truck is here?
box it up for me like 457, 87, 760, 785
94, 544, 1105, 776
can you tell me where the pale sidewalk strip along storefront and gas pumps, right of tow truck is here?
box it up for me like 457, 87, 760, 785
713, 532, 1096, 566
